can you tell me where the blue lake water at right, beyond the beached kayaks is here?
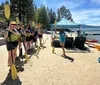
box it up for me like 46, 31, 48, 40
72, 28, 100, 43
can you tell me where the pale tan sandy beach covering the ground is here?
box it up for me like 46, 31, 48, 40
0, 34, 100, 85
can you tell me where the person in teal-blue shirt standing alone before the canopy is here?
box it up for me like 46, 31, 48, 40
59, 28, 66, 57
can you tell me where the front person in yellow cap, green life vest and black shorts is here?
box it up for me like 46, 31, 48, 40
4, 21, 20, 67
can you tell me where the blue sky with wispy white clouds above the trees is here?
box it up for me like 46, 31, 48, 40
0, 0, 100, 25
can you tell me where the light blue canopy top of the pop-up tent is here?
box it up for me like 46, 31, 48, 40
51, 18, 80, 29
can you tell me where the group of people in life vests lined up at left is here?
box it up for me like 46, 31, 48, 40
4, 21, 43, 70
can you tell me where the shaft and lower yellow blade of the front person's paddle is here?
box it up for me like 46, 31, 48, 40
10, 33, 17, 80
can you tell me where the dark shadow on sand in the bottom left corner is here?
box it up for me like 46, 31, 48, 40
1, 72, 22, 85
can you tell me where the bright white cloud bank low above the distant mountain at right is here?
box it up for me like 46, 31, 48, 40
72, 9, 100, 25
